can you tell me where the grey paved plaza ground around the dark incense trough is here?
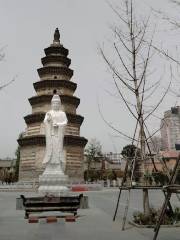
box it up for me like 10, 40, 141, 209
0, 189, 180, 240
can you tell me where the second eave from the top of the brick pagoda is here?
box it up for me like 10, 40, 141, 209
41, 55, 71, 67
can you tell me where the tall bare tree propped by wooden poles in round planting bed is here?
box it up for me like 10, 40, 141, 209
100, 0, 172, 218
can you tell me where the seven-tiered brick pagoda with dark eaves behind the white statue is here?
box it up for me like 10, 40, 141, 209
18, 28, 87, 181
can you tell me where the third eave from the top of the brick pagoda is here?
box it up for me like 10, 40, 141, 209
37, 66, 73, 77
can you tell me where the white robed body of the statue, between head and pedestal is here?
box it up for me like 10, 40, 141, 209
43, 110, 67, 171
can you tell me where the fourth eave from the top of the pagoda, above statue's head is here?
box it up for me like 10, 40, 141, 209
33, 80, 77, 91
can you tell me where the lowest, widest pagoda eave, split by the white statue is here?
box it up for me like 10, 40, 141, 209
17, 135, 88, 147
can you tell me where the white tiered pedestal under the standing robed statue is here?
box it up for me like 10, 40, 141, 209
38, 164, 69, 196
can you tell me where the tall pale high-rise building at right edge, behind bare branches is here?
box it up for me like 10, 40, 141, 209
161, 106, 180, 150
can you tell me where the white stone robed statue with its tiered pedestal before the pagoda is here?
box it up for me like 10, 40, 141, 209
39, 94, 68, 196
